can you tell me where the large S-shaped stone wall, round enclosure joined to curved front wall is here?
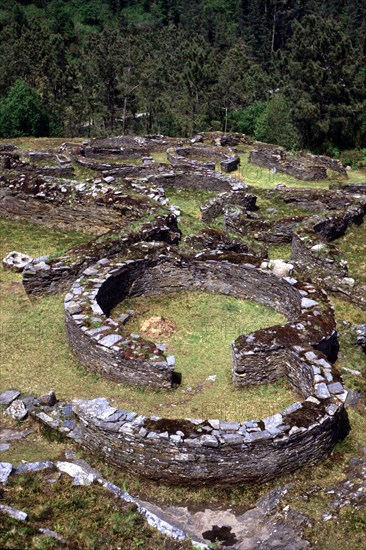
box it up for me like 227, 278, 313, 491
65, 254, 348, 485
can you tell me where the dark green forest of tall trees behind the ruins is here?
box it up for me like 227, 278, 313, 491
0, 0, 366, 155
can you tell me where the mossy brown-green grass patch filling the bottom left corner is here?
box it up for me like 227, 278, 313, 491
0, 472, 192, 550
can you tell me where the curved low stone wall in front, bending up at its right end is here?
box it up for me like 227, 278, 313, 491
27, 346, 349, 486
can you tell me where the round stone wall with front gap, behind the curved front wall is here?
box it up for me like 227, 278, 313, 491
65, 247, 338, 394
